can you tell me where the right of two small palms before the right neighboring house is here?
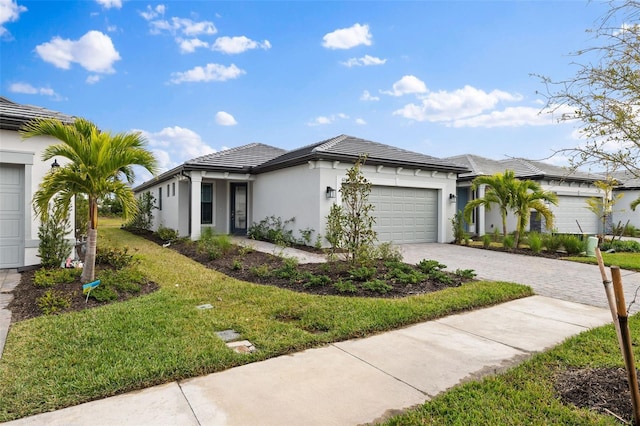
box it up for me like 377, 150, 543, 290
513, 180, 558, 247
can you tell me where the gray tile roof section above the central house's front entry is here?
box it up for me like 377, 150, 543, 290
184, 143, 287, 172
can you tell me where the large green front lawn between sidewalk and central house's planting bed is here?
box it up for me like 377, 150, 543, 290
0, 225, 532, 422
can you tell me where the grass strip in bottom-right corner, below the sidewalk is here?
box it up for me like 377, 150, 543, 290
386, 315, 640, 426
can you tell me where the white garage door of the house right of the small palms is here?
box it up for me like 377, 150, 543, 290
553, 195, 600, 234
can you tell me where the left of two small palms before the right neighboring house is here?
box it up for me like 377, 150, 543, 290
464, 170, 518, 237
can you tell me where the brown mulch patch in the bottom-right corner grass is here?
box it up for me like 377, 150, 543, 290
554, 368, 633, 423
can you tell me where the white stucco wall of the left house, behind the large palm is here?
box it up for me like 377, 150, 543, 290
0, 130, 75, 266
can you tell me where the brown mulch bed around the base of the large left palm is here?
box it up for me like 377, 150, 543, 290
9, 266, 158, 322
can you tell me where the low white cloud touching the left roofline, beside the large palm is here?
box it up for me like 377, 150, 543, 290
134, 126, 216, 172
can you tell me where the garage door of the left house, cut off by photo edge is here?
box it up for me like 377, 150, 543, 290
0, 164, 24, 268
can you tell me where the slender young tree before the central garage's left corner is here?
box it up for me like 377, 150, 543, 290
327, 156, 378, 265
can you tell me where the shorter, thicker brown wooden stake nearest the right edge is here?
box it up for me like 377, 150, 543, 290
611, 266, 640, 425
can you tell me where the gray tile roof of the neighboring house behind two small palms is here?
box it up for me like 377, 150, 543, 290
446, 154, 605, 182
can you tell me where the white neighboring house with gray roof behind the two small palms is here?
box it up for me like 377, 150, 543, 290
447, 154, 604, 235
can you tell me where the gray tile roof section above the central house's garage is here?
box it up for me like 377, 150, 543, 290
255, 135, 468, 173
